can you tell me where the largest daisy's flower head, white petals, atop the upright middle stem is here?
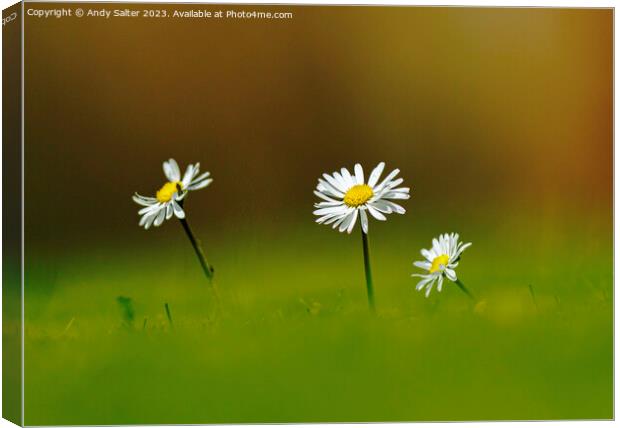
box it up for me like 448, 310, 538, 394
314, 162, 409, 233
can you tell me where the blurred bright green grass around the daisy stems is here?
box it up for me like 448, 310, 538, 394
25, 221, 613, 425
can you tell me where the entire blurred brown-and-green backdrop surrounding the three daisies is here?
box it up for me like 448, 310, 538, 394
19, 3, 613, 425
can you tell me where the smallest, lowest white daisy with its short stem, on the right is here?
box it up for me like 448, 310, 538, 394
411, 233, 472, 297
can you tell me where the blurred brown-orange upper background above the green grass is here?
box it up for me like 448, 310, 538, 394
25, 3, 613, 244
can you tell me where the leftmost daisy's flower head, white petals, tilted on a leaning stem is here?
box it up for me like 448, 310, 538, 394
133, 159, 213, 229
